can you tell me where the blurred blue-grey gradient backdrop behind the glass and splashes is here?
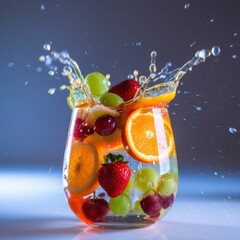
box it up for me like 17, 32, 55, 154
0, 0, 240, 176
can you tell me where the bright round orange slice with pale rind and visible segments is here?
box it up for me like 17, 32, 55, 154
122, 108, 174, 164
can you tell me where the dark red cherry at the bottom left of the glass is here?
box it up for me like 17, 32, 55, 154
82, 198, 109, 222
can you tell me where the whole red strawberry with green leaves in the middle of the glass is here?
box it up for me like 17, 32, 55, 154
98, 153, 131, 198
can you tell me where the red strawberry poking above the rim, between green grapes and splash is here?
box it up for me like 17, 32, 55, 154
109, 79, 141, 102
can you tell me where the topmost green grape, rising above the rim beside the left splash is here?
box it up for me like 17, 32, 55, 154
85, 72, 109, 98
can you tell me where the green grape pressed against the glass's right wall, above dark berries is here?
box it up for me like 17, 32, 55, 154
157, 173, 178, 196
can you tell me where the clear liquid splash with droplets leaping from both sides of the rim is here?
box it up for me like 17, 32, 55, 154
39, 44, 220, 108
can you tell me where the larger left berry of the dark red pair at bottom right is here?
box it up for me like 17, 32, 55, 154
140, 193, 163, 217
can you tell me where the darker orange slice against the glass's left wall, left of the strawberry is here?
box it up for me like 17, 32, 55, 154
68, 142, 100, 196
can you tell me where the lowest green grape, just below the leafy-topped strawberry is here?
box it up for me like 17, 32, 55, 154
109, 194, 132, 216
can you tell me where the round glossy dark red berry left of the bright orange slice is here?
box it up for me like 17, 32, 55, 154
93, 115, 117, 136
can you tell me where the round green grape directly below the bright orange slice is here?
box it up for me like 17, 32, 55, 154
134, 168, 160, 193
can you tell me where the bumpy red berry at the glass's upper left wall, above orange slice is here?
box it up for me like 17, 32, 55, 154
73, 118, 93, 141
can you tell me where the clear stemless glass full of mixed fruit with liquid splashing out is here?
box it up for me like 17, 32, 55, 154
40, 47, 210, 228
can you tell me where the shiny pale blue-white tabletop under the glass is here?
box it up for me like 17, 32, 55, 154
0, 168, 240, 240
